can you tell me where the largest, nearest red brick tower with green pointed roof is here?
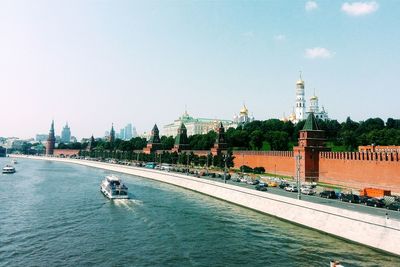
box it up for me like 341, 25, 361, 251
293, 112, 330, 182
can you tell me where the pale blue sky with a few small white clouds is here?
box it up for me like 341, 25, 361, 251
0, 0, 400, 138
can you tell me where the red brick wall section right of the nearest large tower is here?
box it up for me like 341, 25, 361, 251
319, 152, 400, 193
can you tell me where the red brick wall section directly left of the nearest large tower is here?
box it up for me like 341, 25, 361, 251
233, 151, 295, 176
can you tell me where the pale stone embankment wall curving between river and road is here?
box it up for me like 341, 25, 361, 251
10, 156, 400, 255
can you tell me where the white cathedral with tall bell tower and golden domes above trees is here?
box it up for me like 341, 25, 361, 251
282, 73, 329, 123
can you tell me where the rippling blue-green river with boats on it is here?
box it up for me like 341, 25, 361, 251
0, 158, 400, 266
